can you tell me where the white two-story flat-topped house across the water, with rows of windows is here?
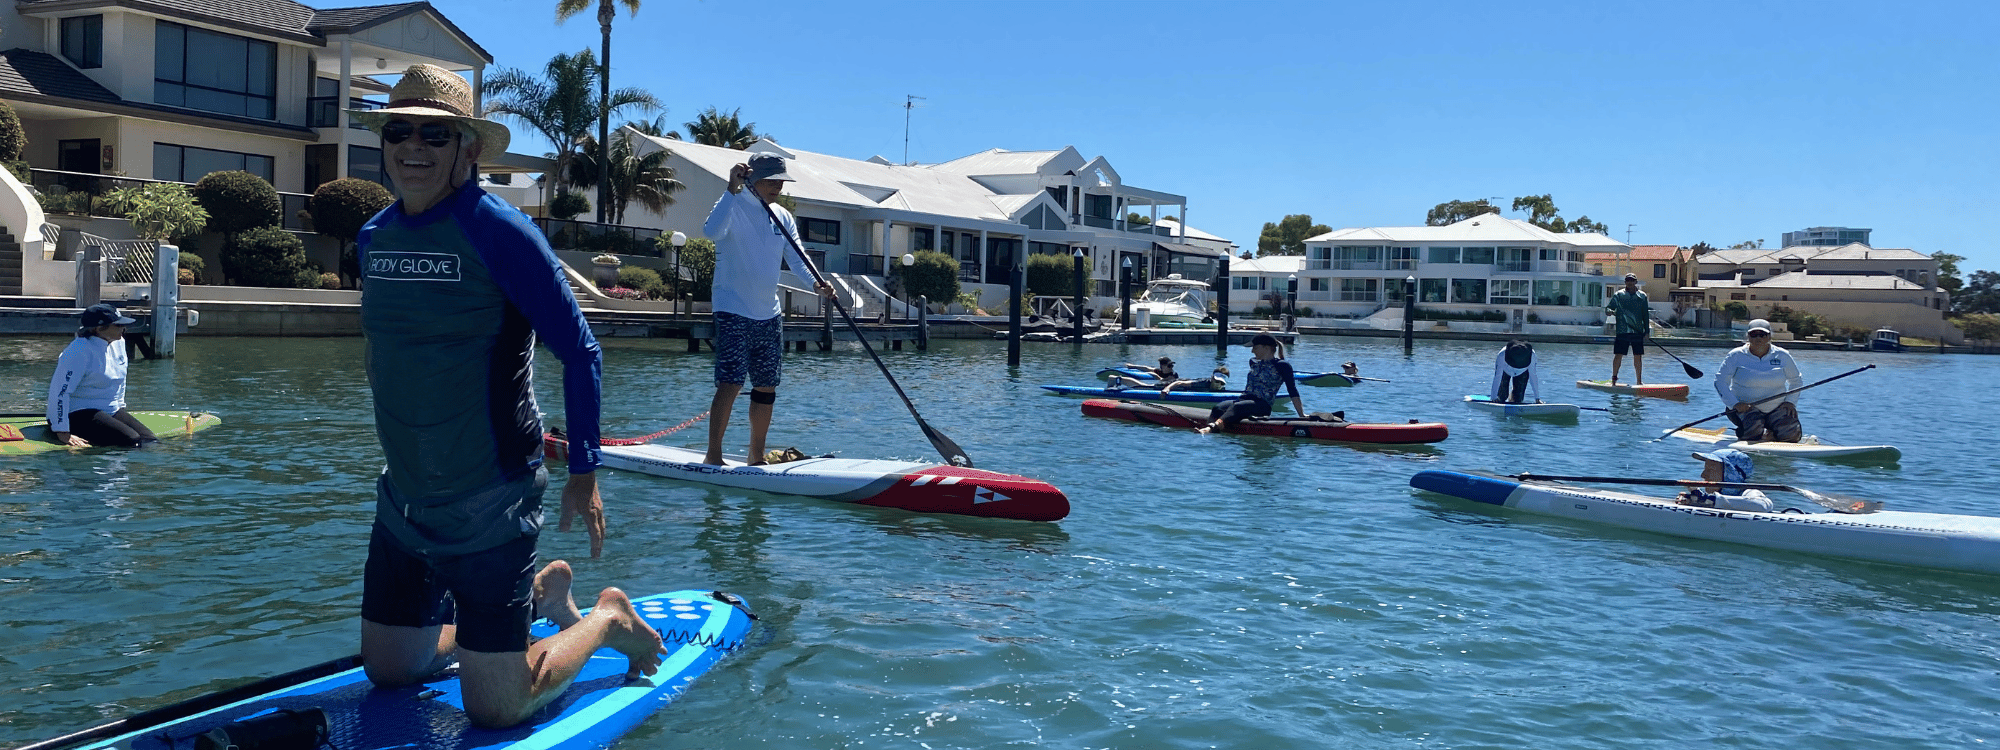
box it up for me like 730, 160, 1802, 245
1298, 214, 1630, 324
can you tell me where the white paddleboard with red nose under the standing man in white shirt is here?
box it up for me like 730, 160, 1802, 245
546, 436, 1070, 520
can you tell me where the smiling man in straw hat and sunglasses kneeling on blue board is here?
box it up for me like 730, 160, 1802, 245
352, 64, 664, 728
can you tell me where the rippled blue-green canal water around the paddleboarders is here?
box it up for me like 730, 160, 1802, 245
0, 338, 2000, 750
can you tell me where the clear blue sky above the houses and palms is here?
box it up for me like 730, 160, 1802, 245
442, 0, 2000, 272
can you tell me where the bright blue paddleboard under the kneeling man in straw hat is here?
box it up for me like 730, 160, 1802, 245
64, 590, 750, 750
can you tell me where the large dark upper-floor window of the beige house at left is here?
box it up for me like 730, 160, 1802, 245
152, 20, 278, 120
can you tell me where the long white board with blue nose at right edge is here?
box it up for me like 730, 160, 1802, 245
1410, 470, 2000, 574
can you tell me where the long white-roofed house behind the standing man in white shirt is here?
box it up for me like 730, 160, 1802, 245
620, 130, 1236, 298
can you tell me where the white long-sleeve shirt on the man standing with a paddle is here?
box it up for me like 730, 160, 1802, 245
702, 186, 804, 320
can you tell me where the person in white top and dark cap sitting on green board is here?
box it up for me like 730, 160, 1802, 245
48, 302, 160, 448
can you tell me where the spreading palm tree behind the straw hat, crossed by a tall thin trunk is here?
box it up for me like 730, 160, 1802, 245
484, 48, 660, 212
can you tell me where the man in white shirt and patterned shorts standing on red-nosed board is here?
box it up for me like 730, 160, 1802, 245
702, 152, 834, 466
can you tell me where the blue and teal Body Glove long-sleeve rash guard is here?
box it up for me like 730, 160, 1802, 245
356, 182, 602, 502
